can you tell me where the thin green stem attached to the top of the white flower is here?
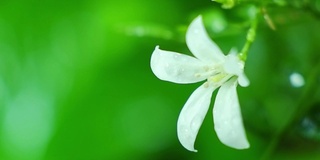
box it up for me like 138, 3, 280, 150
239, 12, 258, 62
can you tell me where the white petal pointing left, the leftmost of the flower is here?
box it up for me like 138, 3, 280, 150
150, 46, 207, 83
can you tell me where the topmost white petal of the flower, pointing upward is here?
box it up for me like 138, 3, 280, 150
186, 16, 224, 63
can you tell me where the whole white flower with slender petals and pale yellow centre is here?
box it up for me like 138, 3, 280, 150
151, 16, 249, 152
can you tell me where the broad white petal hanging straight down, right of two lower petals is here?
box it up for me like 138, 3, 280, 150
213, 78, 249, 149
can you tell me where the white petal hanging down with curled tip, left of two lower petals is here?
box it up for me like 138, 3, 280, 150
177, 84, 215, 152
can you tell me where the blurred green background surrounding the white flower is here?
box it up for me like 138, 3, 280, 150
0, 0, 320, 160
